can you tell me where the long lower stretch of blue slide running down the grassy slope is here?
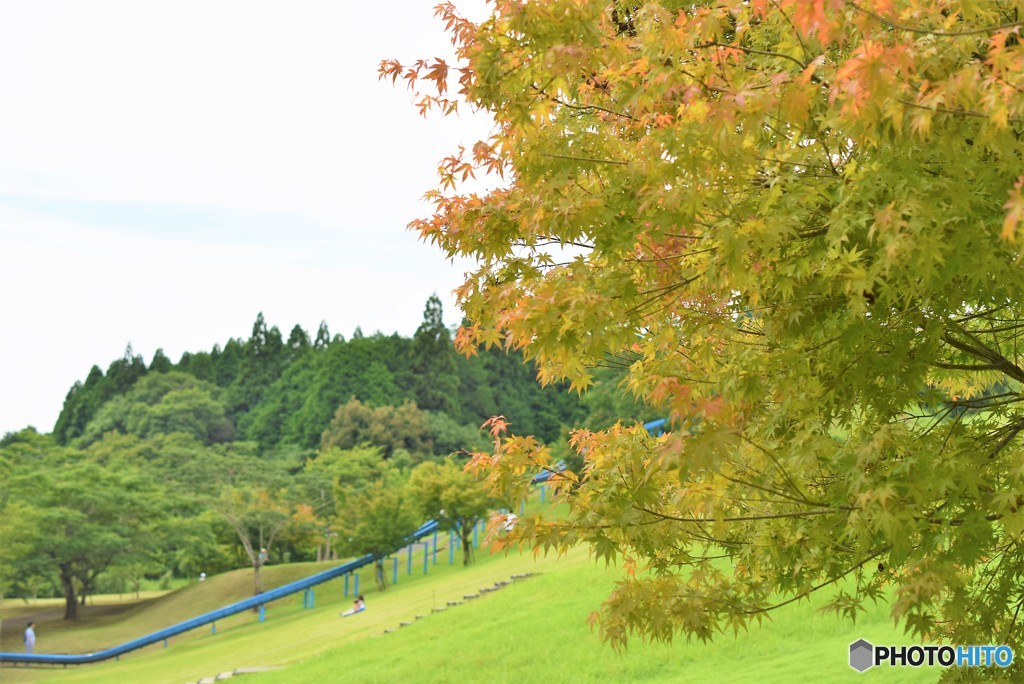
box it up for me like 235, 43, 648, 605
0, 520, 439, 666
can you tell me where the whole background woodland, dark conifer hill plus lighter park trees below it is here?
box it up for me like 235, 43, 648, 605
0, 297, 638, 619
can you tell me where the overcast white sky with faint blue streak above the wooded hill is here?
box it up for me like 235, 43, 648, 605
0, 0, 487, 434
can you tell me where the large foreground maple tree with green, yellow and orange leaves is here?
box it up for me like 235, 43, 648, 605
380, 0, 1024, 665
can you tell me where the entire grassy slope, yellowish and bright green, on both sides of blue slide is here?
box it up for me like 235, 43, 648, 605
2, 540, 937, 684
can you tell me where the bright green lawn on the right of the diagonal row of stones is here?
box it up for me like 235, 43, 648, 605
247, 554, 937, 684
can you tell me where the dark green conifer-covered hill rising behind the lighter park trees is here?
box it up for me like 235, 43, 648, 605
53, 296, 583, 448
